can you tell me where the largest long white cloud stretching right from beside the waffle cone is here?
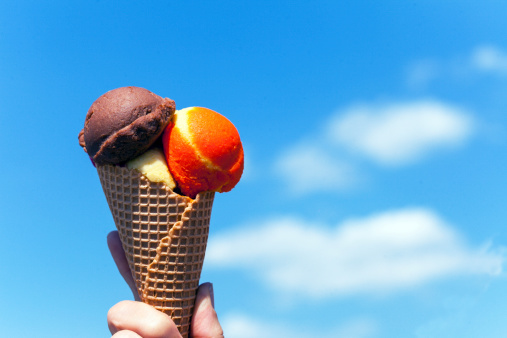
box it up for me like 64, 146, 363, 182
206, 208, 504, 299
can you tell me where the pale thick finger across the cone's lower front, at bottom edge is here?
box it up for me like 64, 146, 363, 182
107, 300, 181, 338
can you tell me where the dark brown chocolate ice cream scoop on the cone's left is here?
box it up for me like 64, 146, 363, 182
79, 87, 175, 165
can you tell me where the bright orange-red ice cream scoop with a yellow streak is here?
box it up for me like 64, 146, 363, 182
162, 107, 244, 198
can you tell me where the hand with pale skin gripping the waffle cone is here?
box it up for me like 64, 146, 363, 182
107, 231, 223, 338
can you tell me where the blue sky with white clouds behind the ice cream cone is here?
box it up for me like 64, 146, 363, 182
0, 0, 507, 338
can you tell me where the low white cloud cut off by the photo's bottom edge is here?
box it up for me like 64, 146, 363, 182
221, 313, 377, 338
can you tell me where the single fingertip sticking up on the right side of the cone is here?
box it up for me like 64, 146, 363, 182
190, 283, 224, 338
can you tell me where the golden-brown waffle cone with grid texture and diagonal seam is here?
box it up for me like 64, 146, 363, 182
97, 165, 215, 337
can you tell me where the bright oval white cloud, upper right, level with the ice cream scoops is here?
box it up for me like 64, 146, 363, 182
329, 101, 473, 165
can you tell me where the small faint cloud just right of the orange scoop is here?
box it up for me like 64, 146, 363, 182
275, 144, 358, 195
